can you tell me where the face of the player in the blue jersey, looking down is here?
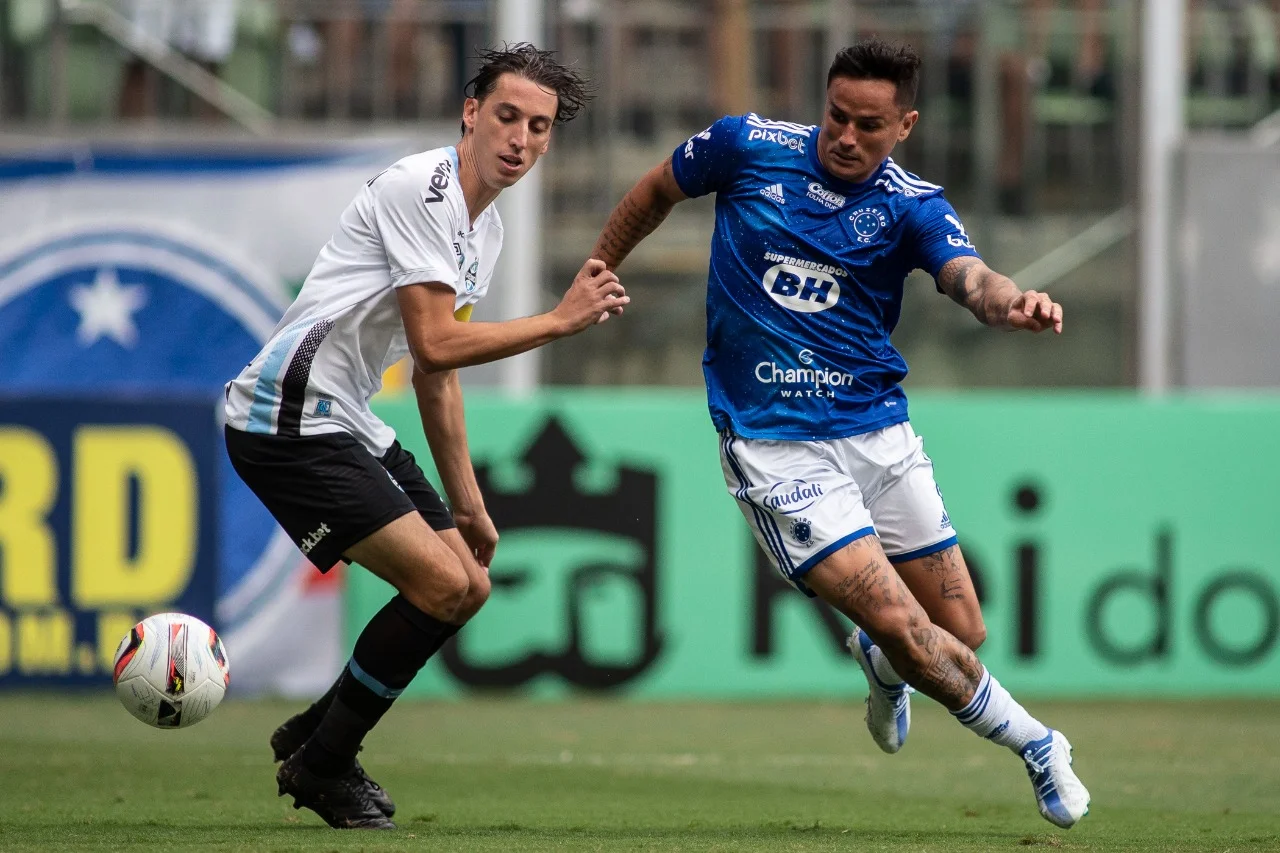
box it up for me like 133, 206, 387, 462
818, 77, 920, 183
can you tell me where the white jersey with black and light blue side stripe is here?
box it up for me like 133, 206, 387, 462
225, 146, 502, 456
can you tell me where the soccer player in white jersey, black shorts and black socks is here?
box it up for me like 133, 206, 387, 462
225, 44, 627, 829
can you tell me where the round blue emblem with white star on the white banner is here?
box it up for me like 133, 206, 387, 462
0, 227, 283, 625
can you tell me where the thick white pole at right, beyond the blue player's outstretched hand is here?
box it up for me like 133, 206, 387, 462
1138, 0, 1187, 394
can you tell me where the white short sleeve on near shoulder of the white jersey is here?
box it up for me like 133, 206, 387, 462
372, 163, 458, 289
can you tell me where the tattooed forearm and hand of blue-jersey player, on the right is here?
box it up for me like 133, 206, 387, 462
937, 256, 1062, 334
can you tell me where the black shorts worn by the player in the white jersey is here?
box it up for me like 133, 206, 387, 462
224, 427, 457, 571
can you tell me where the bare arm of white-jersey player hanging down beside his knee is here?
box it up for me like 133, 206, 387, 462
413, 368, 498, 567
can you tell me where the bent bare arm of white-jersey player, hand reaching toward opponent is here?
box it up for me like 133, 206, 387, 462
396, 259, 631, 373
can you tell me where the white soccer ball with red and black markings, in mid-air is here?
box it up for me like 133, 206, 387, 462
111, 613, 232, 729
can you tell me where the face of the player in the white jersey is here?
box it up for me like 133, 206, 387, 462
462, 74, 558, 190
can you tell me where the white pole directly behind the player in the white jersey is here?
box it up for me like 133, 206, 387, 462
494, 0, 542, 394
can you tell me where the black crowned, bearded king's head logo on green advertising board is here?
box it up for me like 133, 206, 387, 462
442, 416, 662, 689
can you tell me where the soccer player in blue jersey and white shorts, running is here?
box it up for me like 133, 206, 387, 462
591, 38, 1089, 827
